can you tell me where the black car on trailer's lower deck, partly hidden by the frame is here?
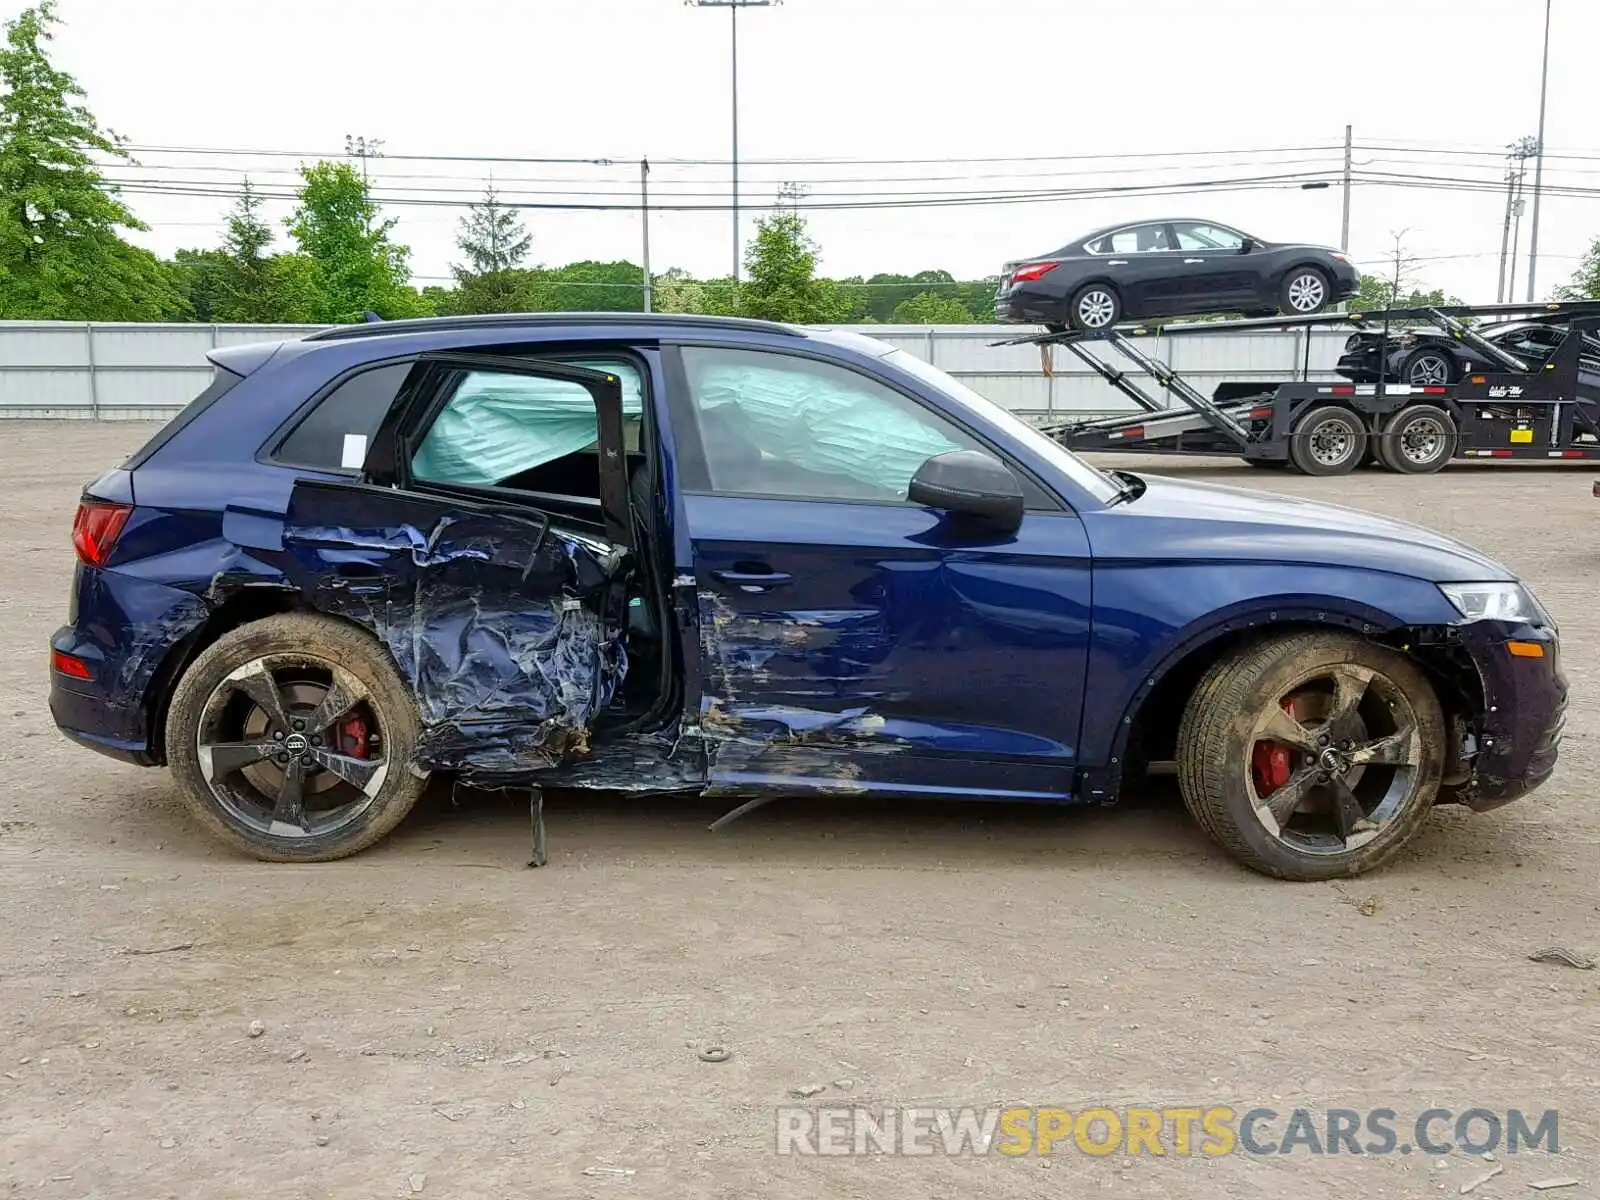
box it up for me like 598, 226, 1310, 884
1334, 321, 1600, 387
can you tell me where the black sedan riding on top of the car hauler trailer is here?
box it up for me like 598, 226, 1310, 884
995, 219, 1360, 330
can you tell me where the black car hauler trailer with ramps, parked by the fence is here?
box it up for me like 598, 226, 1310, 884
998, 301, 1600, 475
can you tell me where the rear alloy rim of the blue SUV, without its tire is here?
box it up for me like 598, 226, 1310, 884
195, 654, 389, 838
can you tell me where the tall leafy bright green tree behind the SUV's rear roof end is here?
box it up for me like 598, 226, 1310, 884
285, 162, 427, 323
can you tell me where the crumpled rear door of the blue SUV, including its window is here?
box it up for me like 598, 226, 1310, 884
285, 355, 637, 781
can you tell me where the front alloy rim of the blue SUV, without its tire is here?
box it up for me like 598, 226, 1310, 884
1246, 662, 1424, 854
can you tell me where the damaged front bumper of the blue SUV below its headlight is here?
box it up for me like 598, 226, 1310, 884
1450, 621, 1566, 813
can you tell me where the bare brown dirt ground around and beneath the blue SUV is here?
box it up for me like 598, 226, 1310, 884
0, 422, 1600, 1200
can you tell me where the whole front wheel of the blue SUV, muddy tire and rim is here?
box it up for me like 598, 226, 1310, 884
1178, 632, 1445, 880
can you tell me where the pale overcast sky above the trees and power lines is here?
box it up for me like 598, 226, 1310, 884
34, 0, 1600, 301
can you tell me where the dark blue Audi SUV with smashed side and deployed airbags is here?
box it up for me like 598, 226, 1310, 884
50, 314, 1566, 878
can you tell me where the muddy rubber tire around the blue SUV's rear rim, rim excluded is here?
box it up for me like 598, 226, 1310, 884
166, 613, 427, 862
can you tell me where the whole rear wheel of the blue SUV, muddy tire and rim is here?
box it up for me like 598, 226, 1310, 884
166, 613, 426, 862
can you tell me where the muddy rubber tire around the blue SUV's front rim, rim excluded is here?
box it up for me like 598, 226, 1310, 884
1178, 630, 1445, 880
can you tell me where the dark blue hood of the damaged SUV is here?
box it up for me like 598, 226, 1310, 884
1091, 475, 1517, 582
